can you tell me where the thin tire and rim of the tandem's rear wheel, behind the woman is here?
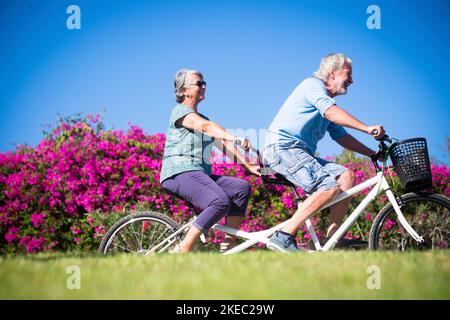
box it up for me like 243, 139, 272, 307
98, 211, 181, 255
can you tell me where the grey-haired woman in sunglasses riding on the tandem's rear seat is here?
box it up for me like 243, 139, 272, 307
160, 69, 259, 253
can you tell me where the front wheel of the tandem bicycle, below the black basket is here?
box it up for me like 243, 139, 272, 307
369, 193, 450, 251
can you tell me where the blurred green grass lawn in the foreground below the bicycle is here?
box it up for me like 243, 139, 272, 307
0, 250, 450, 299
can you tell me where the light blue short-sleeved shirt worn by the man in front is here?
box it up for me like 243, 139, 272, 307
266, 78, 347, 155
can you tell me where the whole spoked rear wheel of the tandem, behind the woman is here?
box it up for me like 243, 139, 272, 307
98, 211, 182, 254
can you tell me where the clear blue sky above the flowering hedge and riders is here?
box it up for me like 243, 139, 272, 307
0, 0, 450, 164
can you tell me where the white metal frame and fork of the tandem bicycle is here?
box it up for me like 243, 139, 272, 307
146, 171, 424, 254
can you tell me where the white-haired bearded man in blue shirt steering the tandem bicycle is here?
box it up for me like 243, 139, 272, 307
263, 54, 384, 252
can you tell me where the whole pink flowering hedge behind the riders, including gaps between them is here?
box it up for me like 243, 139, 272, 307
0, 116, 450, 254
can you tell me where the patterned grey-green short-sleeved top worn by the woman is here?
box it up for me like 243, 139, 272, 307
159, 104, 214, 183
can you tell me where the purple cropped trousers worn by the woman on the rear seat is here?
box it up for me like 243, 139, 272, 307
161, 171, 250, 232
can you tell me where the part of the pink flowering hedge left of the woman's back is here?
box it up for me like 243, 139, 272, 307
0, 116, 169, 253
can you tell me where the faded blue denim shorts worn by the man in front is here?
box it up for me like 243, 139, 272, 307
263, 141, 347, 195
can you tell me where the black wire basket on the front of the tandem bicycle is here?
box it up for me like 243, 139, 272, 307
390, 138, 433, 192
